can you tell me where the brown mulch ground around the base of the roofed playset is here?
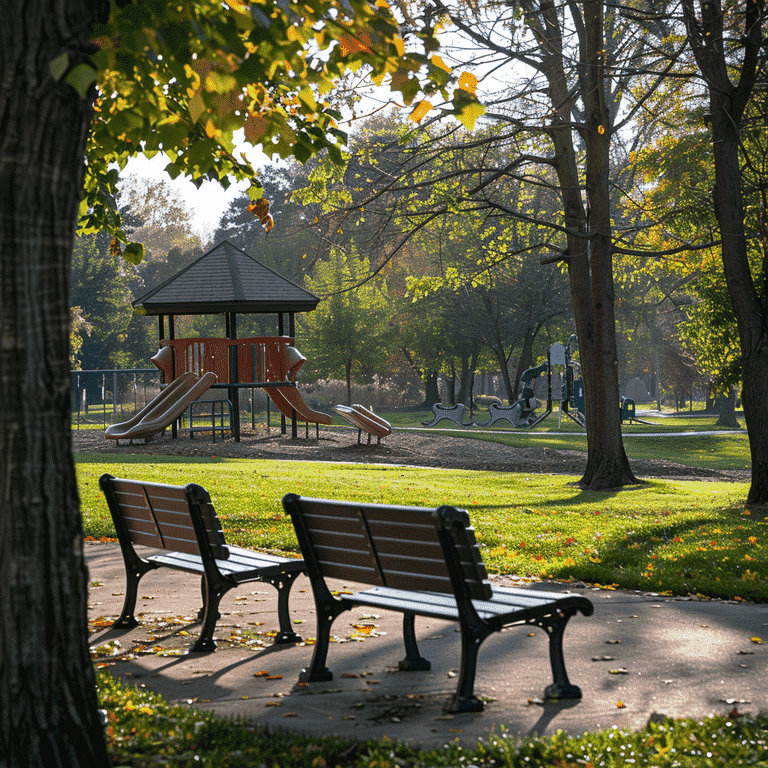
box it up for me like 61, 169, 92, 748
72, 425, 751, 482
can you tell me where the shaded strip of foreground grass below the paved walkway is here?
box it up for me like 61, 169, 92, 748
99, 673, 768, 768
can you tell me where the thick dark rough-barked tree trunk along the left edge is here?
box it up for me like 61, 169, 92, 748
0, 0, 109, 768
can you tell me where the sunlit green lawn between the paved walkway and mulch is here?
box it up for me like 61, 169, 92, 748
78, 454, 768, 602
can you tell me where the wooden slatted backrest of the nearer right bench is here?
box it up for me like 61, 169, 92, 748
283, 494, 492, 600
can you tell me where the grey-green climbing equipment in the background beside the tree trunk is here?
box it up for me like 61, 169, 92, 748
422, 335, 588, 429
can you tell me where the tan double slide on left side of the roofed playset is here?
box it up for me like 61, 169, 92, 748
104, 372, 216, 440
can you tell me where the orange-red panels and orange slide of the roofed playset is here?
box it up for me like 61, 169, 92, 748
152, 336, 333, 439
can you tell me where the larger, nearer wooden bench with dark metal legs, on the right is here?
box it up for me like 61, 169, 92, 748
283, 494, 593, 712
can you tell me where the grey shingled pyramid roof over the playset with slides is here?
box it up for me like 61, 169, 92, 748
132, 240, 320, 315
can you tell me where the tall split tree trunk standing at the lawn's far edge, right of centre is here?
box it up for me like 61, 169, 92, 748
541, 0, 637, 490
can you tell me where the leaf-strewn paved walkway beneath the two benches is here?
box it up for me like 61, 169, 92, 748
85, 544, 768, 747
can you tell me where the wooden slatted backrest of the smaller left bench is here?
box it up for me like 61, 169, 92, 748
99, 474, 229, 560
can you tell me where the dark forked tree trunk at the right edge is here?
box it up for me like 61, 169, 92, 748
683, 0, 768, 504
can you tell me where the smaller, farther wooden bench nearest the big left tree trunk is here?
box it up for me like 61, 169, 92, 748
99, 474, 305, 652
